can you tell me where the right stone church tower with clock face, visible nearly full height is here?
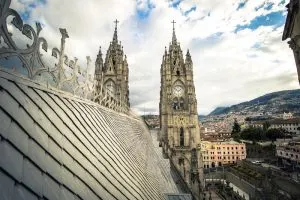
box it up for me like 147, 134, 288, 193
159, 21, 203, 198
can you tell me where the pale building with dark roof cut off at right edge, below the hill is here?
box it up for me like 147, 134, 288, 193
276, 141, 300, 169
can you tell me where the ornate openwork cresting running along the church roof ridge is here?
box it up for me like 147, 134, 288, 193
0, 0, 129, 112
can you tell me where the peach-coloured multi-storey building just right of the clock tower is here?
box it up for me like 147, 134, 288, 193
201, 141, 246, 168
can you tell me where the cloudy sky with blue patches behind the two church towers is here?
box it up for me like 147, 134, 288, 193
11, 0, 299, 115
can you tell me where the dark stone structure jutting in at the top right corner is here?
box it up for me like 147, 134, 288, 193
282, 0, 300, 83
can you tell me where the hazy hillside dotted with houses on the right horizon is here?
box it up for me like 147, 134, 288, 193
209, 89, 300, 116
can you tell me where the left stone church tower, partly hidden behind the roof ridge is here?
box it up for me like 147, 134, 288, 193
94, 20, 130, 107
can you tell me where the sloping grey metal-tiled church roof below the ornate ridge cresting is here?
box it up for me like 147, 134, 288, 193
0, 71, 176, 200
